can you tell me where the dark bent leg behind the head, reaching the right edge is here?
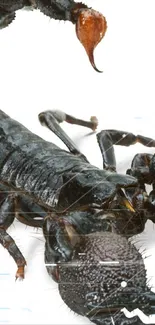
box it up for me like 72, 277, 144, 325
97, 130, 155, 171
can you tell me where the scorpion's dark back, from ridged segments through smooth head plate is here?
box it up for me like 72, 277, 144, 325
0, 111, 136, 210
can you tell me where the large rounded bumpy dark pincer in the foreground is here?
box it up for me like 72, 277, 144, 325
58, 232, 155, 325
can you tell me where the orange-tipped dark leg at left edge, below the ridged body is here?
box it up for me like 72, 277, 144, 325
0, 195, 26, 279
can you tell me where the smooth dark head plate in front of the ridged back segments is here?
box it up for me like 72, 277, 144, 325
58, 169, 137, 211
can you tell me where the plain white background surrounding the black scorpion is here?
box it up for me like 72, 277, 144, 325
0, 0, 155, 324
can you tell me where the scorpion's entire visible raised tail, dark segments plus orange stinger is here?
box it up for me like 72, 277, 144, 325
0, 0, 107, 72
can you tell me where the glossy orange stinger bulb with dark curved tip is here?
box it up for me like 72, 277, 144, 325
76, 9, 107, 72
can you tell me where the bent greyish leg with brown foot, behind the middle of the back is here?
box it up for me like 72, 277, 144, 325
39, 110, 98, 161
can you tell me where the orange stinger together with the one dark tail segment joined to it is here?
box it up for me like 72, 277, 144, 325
37, 0, 107, 72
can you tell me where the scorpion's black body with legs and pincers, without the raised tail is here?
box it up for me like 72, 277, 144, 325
0, 111, 155, 325
